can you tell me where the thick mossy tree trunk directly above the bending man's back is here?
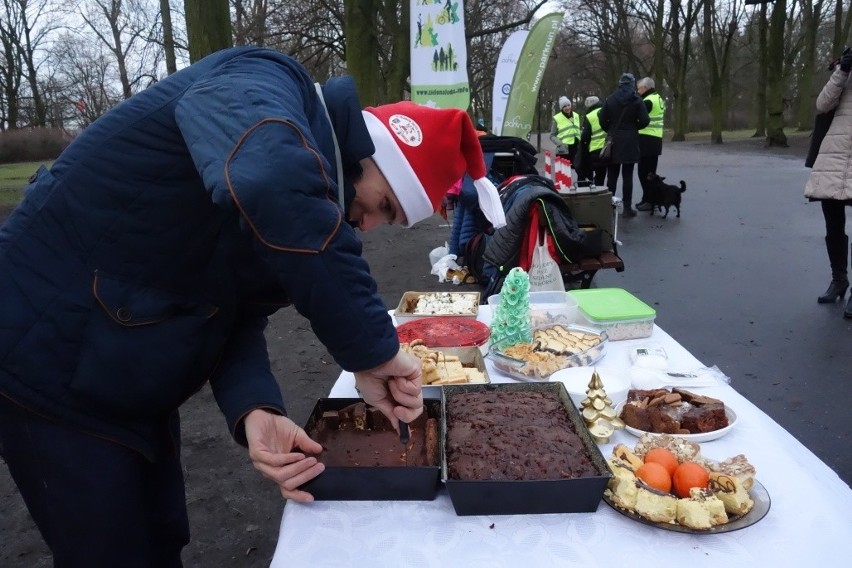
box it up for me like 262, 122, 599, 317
183, 0, 234, 63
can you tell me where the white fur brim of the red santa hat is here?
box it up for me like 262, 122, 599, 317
361, 111, 434, 227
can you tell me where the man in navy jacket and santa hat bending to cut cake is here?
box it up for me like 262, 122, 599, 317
0, 48, 505, 567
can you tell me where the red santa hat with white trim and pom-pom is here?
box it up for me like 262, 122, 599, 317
363, 101, 506, 228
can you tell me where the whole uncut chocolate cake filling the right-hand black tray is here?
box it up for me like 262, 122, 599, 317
446, 391, 598, 481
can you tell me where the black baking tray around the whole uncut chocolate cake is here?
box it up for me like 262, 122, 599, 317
440, 382, 612, 516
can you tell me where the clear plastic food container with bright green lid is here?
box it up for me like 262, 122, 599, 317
568, 288, 657, 341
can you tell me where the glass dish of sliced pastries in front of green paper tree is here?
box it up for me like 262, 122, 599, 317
488, 325, 608, 381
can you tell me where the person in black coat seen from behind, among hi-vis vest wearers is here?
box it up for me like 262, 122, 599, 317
600, 73, 650, 217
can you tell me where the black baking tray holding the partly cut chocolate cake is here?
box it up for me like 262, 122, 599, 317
299, 398, 443, 501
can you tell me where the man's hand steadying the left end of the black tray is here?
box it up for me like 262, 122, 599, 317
244, 409, 325, 501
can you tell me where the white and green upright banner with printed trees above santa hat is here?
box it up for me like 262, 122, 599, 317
409, 0, 470, 110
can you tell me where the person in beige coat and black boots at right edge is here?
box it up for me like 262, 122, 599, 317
805, 47, 852, 318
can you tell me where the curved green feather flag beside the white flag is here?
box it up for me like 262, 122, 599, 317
501, 12, 563, 140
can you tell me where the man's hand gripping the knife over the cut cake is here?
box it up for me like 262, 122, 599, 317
355, 351, 423, 430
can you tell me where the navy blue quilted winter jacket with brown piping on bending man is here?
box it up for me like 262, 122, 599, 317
0, 48, 399, 459
